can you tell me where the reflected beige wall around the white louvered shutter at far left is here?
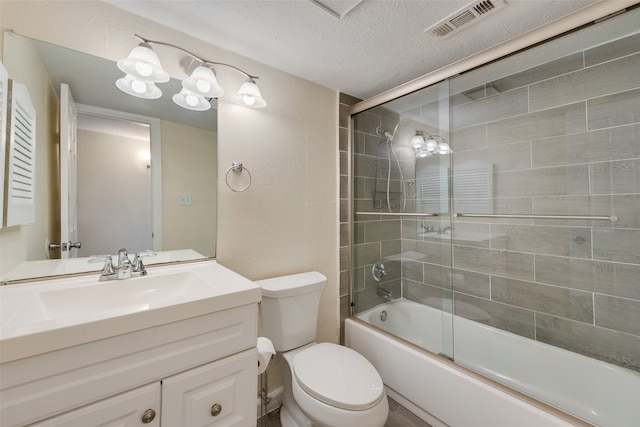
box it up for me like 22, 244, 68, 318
0, 29, 60, 275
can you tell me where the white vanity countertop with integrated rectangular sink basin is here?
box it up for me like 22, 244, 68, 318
0, 261, 261, 363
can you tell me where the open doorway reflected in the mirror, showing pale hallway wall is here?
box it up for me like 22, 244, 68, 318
77, 112, 153, 256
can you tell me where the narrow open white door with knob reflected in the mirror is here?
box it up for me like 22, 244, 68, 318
60, 83, 80, 258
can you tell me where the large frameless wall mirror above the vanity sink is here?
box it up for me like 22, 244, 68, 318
0, 32, 217, 282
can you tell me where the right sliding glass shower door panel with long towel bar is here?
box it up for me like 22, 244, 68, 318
451, 10, 640, 425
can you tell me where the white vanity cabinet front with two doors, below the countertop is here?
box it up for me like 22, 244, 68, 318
0, 301, 258, 427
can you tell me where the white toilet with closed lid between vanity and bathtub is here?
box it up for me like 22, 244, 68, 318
256, 272, 389, 427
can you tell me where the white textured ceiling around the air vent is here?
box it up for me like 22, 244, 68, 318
106, 0, 597, 99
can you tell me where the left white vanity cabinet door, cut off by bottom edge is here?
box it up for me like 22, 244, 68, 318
31, 383, 160, 427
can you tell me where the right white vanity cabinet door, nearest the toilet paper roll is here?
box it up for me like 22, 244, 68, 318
162, 348, 258, 427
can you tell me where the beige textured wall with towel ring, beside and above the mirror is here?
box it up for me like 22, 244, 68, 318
0, 0, 338, 394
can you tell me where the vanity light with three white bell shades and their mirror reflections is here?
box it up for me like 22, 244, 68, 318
116, 34, 267, 111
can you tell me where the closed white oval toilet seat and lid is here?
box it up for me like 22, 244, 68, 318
293, 343, 384, 411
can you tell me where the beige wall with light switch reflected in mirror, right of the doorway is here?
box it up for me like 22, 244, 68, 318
161, 121, 218, 255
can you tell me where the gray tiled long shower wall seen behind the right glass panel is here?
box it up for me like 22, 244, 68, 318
410, 35, 640, 371
